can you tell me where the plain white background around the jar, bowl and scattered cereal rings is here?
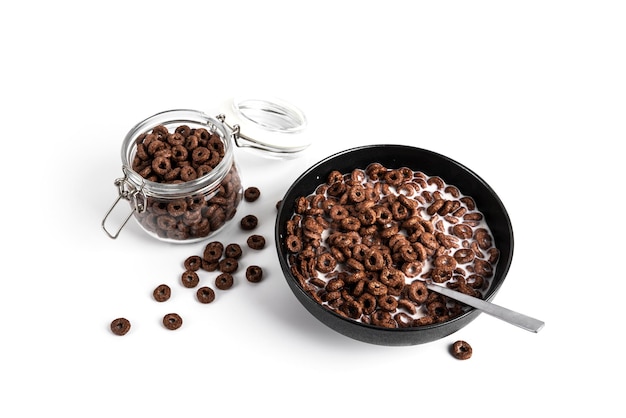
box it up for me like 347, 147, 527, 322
0, 0, 626, 417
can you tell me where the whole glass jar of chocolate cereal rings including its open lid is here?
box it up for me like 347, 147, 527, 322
102, 95, 311, 243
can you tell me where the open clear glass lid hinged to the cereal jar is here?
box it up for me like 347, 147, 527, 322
217, 96, 311, 157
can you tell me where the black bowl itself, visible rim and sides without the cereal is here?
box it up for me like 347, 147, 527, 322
275, 145, 513, 346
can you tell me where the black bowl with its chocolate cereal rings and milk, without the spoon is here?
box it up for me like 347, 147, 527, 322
275, 144, 513, 346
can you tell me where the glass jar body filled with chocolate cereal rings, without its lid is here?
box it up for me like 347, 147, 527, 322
102, 109, 243, 243
